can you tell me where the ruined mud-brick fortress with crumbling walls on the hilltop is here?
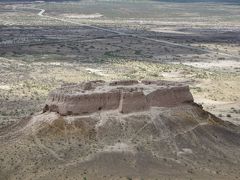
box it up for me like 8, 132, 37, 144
43, 80, 193, 115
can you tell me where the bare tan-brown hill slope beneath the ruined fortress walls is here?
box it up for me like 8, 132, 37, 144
0, 83, 240, 180
